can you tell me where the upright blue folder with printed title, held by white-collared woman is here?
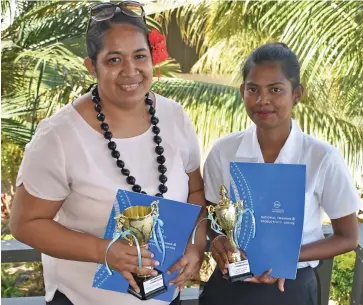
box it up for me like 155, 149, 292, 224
230, 162, 306, 279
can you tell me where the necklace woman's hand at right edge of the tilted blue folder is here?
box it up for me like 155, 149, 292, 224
168, 244, 204, 289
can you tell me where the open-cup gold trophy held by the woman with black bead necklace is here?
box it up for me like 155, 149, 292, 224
116, 201, 167, 300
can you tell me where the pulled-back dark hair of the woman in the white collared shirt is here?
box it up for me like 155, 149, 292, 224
242, 42, 300, 88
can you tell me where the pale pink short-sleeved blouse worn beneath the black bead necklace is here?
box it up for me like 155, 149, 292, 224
17, 94, 200, 305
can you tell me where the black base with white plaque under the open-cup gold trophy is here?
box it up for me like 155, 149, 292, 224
127, 269, 167, 300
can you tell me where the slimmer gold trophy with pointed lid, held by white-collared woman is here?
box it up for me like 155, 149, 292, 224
208, 185, 253, 282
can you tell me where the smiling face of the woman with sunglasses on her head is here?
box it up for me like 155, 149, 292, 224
87, 24, 153, 107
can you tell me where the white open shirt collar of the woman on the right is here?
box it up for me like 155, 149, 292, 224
236, 120, 304, 164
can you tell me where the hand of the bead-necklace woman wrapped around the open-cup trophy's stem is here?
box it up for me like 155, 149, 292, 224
107, 240, 159, 292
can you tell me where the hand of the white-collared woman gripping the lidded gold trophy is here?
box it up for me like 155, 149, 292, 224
212, 235, 247, 274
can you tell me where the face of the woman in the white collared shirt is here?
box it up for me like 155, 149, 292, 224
241, 62, 303, 129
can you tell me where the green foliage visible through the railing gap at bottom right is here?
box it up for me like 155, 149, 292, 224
330, 251, 356, 305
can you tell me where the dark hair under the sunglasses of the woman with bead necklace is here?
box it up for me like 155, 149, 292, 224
86, 9, 151, 62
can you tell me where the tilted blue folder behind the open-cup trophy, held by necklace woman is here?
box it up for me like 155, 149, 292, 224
93, 190, 201, 302
